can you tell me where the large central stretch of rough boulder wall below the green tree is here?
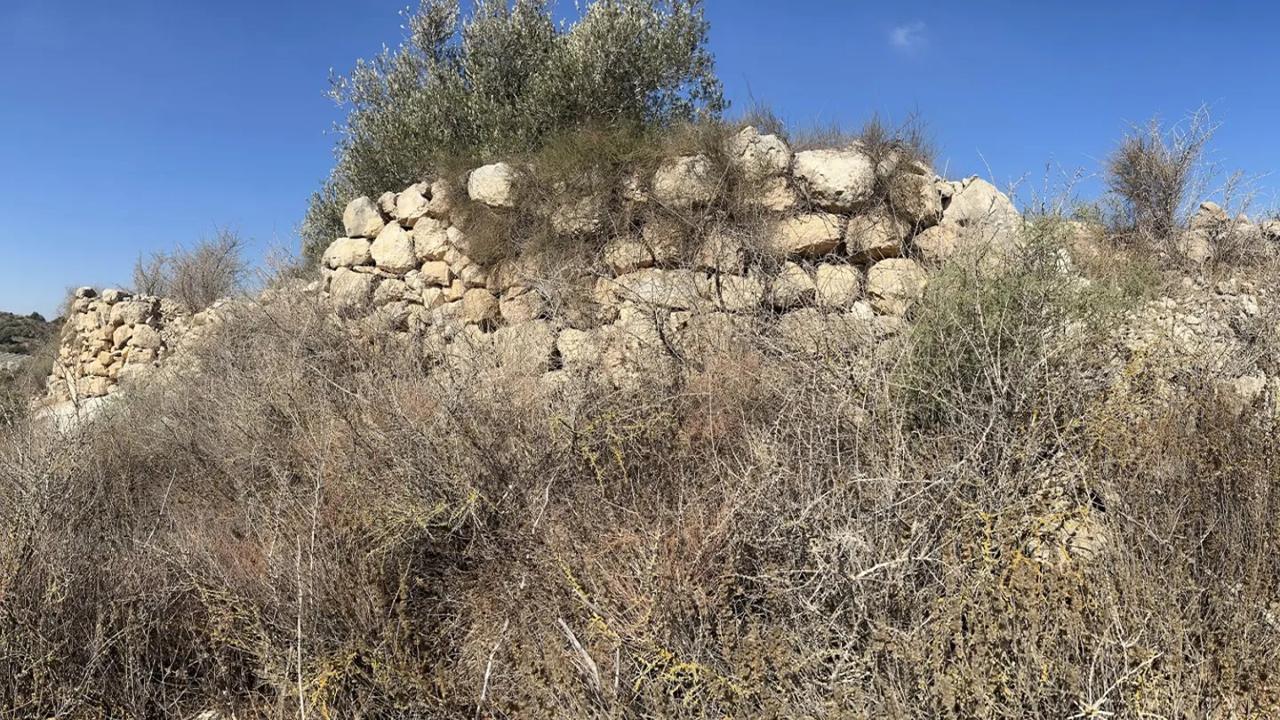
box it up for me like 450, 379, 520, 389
304, 128, 1023, 386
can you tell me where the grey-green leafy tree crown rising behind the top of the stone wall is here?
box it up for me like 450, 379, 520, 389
302, 0, 724, 262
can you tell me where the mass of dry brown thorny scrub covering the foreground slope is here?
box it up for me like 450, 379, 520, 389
0, 215, 1280, 717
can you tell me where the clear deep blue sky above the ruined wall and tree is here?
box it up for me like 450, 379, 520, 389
0, 0, 1280, 314
